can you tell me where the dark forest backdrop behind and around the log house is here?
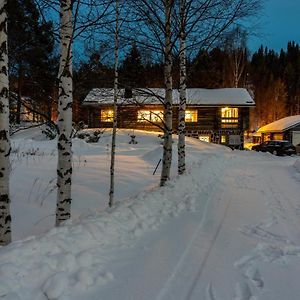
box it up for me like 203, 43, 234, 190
8, 0, 300, 130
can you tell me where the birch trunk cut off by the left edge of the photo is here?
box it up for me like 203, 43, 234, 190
0, 0, 11, 245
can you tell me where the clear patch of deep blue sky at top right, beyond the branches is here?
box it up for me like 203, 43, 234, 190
248, 0, 300, 51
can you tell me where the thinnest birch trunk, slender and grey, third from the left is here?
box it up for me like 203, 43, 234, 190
108, 0, 119, 207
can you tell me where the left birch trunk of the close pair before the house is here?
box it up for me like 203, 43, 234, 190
160, 0, 173, 186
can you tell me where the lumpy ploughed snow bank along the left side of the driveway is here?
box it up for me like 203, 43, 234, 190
0, 131, 231, 300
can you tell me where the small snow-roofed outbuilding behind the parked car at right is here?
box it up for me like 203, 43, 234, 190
258, 115, 300, 146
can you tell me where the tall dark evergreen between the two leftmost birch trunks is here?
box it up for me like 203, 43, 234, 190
8, 0, 57, 123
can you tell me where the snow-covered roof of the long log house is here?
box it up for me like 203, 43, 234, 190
83, 88, 255, 106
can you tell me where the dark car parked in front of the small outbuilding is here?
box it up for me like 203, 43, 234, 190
252, 141, 296, 155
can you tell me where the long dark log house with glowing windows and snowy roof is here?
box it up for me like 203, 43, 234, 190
82, 88, 255, 148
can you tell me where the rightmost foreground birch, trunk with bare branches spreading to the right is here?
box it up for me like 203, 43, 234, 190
177, 0, 262, 175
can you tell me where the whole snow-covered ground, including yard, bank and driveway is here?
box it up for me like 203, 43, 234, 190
0, 130, 300, 300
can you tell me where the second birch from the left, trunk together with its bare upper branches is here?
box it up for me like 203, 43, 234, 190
36, 0, 112, 225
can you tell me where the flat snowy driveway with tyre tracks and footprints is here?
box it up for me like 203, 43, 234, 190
85, 152, 300, 300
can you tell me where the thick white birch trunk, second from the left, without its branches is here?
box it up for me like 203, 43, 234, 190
56, 0, 73, 226
